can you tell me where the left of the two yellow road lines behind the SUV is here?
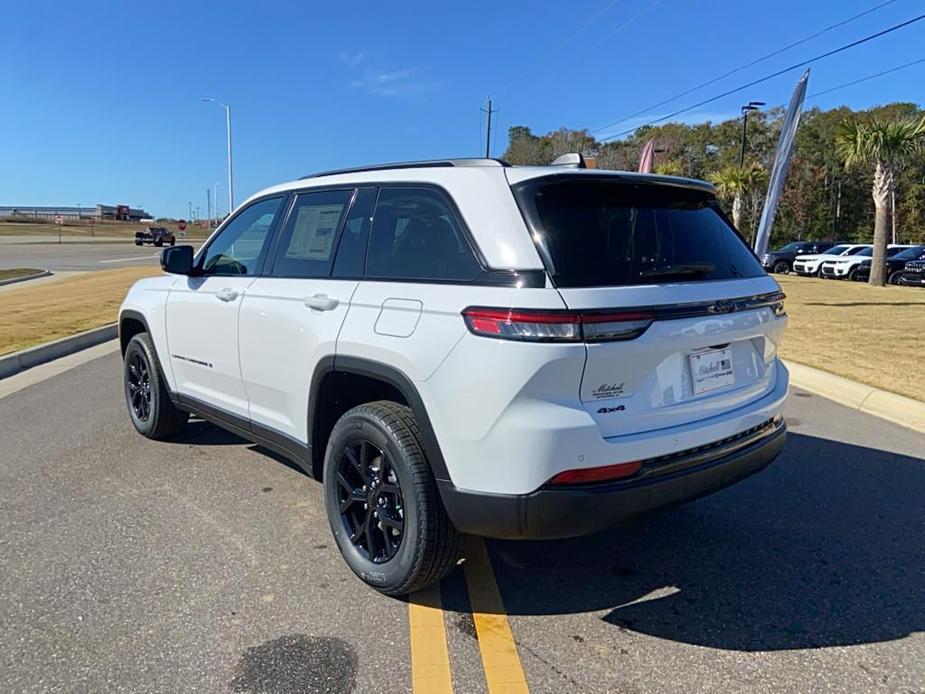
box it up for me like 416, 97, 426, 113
408, 584, 453, 694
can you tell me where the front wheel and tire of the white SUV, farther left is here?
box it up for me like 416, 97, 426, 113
122, 333, 189, 441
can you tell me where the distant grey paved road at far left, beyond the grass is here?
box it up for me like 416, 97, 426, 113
0, 236, 202, 272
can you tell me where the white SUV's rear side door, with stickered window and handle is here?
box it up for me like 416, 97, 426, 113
240, 188, 376, 443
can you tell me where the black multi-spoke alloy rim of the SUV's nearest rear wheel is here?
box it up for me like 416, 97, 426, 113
335, 439, 405, 564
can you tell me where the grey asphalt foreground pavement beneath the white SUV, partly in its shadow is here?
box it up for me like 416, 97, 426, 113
0, 350, 925, 692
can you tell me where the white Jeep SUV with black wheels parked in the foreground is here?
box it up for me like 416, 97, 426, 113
119, 159, 788, 594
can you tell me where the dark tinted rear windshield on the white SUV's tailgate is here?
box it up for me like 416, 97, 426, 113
514, 176, 764, 287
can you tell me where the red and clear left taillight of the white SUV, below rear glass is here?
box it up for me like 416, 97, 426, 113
463, 307, 655, 342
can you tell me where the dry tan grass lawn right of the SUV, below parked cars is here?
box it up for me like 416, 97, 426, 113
775, 275, 925, 400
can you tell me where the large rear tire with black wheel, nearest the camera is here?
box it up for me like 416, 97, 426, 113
323, 400, 462, 595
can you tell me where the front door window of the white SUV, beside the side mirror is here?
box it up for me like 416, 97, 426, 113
202, 197, 284, 275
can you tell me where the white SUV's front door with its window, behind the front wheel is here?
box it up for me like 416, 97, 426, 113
166, 197, 285, 418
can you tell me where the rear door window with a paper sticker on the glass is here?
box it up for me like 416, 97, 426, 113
273, 190, 353, 277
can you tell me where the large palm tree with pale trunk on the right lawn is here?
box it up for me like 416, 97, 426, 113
835, 118, 925, 287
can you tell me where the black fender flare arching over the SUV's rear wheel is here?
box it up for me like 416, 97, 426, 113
308, 355, 451, 482
